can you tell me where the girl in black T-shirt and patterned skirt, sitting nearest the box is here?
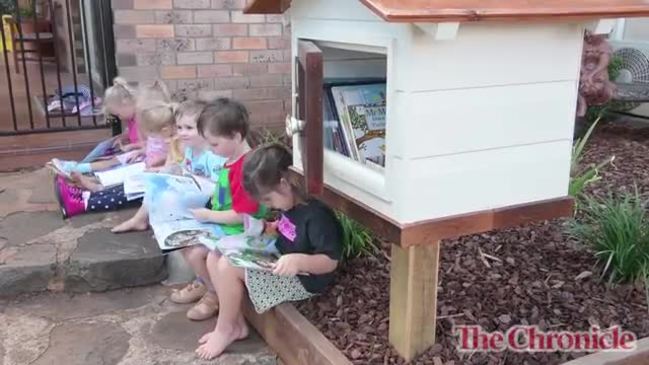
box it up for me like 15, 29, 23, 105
196, 145, 342, 359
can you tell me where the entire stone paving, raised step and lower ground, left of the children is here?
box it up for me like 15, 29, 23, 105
0, 169, 277, 365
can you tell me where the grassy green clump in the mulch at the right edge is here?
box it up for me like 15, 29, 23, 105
569, 189, 649, 283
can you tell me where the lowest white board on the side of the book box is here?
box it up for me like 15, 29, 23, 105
395, 141, 571, 223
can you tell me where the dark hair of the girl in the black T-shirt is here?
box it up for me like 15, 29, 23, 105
243, 143, 296, 199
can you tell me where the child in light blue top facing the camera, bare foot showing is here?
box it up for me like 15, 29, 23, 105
112, 100, 225, 233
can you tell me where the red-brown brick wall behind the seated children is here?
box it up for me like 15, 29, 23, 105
112, 0, 291, 128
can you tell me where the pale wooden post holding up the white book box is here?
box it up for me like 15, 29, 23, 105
390, 241, 440, 361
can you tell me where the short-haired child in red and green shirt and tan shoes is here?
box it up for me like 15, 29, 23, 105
170, 98, 263, 320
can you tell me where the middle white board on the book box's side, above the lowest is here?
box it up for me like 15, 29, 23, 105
400, 81, 577, 158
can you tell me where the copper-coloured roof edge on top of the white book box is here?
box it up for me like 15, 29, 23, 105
245, 0, 649, 22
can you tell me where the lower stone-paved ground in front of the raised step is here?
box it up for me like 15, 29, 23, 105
0, 286, 277, 365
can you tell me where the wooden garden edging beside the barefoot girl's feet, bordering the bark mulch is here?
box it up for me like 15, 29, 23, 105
244, 300, 352, 365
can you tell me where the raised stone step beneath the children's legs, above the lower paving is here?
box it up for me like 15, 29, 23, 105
0, 169, 167, 297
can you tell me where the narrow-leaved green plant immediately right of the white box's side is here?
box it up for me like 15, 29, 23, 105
568, 118, 615, 198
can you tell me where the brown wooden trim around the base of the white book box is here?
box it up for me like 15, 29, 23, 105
290, 168, 574, 247
